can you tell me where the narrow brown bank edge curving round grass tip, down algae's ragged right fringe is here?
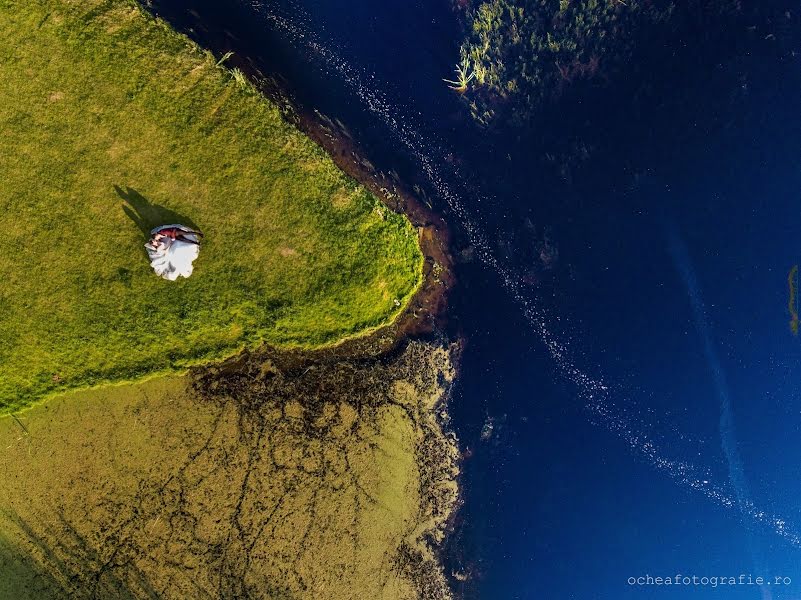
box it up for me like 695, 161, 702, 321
134, 0, 464, 599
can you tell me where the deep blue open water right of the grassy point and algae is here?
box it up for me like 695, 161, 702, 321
145, 0, 801, 600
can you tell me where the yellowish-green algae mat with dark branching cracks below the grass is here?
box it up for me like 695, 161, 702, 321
0, 341, 458, 599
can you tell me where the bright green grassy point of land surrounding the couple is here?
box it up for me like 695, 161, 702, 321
0, 0, 422, 412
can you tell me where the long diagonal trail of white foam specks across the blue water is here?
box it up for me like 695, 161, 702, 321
250, 0, 801, 548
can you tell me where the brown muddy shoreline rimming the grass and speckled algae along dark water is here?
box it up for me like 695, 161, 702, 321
145, 6, 464, 599
